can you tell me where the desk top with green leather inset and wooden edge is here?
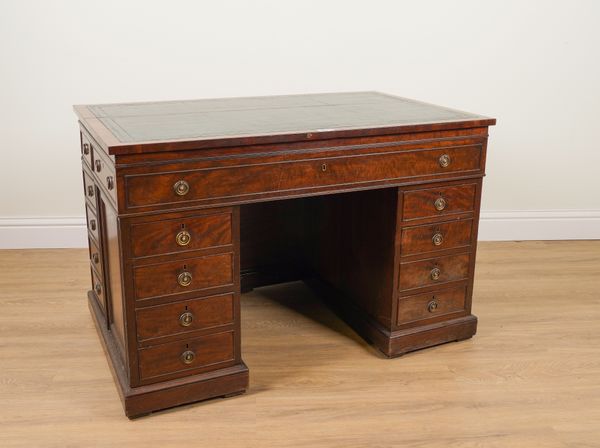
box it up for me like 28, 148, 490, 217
75, 92, 495, 154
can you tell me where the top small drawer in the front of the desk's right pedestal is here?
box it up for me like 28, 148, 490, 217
402, 184, 476, 221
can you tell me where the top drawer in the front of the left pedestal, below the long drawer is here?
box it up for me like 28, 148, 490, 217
131, 212, 233, 257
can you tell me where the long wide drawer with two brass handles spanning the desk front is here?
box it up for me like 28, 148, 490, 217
126, 145, 481, 208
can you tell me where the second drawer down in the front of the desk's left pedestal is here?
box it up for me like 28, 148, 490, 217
134, 253, 233, 300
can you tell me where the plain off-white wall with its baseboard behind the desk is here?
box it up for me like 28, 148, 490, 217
0, 0, 600, 247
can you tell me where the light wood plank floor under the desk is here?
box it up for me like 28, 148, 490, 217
0, 241, 600, 448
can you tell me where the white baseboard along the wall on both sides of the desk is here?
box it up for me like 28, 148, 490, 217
0, 210, 600, 249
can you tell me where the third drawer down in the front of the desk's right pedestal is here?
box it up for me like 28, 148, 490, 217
399, 254, 470, 290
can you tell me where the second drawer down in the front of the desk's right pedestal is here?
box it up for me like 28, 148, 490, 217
400, 219, 473, 255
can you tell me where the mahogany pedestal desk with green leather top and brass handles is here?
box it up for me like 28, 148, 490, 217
75, 92, 495, 417
